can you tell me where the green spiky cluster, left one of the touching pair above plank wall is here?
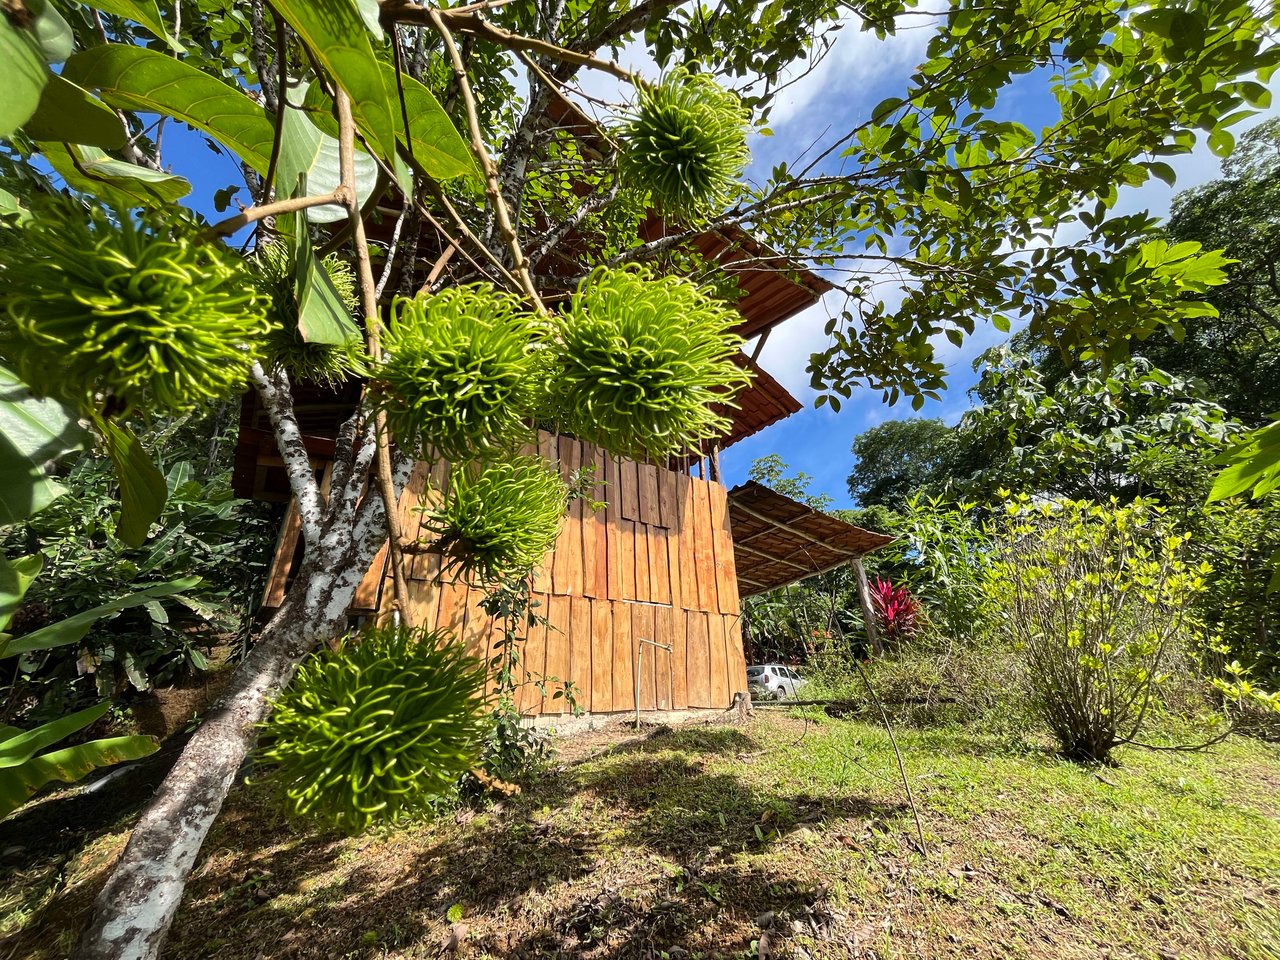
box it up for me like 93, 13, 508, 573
375, 283, 543, 463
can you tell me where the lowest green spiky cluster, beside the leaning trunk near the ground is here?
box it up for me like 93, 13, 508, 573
260, 627, 485, 831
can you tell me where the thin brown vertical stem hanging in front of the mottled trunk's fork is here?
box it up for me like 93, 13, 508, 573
334, 87, 412, 626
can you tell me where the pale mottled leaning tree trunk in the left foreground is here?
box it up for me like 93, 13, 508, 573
72, 468, 407, 960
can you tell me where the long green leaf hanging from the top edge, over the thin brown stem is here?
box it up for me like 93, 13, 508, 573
273, 0, 398, 163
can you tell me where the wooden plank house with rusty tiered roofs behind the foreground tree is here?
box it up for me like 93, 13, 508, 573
236, 232, 888, 714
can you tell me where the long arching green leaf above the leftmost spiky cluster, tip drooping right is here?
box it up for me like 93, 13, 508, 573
63, 44, 275, 174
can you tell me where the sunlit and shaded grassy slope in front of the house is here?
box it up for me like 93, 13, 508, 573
0, 714, 1280, 960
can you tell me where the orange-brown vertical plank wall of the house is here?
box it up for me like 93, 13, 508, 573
361, 433, 746, 713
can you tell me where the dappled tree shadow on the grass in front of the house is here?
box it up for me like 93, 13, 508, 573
149, 728, 905, 960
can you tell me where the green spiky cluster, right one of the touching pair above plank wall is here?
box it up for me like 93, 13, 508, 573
550, 269, 750, 458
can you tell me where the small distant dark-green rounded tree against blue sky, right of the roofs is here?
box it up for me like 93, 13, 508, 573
849, 417, 956, 511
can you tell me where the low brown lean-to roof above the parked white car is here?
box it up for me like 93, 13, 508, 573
728, 480, 893, 596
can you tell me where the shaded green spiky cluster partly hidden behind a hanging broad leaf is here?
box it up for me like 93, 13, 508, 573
253, 243, 369, 387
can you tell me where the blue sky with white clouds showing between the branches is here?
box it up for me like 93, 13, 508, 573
152, 16, 1280, 507
